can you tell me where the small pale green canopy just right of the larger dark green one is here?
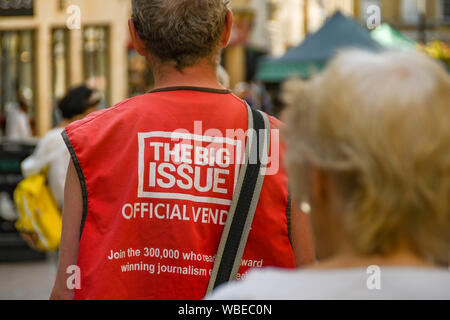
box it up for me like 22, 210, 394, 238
371, 23, 418, 50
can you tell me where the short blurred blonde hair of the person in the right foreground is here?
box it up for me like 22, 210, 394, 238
285, 50, 450, 263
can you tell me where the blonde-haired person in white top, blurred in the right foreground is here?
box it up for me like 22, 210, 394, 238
210, 50, 450, 299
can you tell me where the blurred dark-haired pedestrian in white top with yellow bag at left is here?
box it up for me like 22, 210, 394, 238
22, 85, 101, 210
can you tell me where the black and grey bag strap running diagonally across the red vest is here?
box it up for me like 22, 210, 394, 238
207, 105, 270, 293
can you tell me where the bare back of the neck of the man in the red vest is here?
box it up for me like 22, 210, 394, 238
154, 62, 225, 89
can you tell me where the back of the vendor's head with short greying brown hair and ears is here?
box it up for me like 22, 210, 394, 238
130, 0, 231, 71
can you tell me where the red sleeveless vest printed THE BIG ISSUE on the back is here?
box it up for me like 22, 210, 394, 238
65, 88, 294, 300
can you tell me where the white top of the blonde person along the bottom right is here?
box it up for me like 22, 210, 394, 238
206, 267, 450, 300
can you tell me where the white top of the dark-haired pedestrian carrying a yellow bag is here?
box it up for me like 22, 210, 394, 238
22, 128, 70, 209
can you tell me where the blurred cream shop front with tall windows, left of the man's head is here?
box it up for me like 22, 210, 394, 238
0, 0, 131, 138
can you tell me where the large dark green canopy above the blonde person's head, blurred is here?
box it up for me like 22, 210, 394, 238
256, 12, 383, 82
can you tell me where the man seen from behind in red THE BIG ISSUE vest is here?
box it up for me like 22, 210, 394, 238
52, 0, 313, 299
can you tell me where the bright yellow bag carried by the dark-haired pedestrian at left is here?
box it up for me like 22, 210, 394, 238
14, 169, 62, 252
